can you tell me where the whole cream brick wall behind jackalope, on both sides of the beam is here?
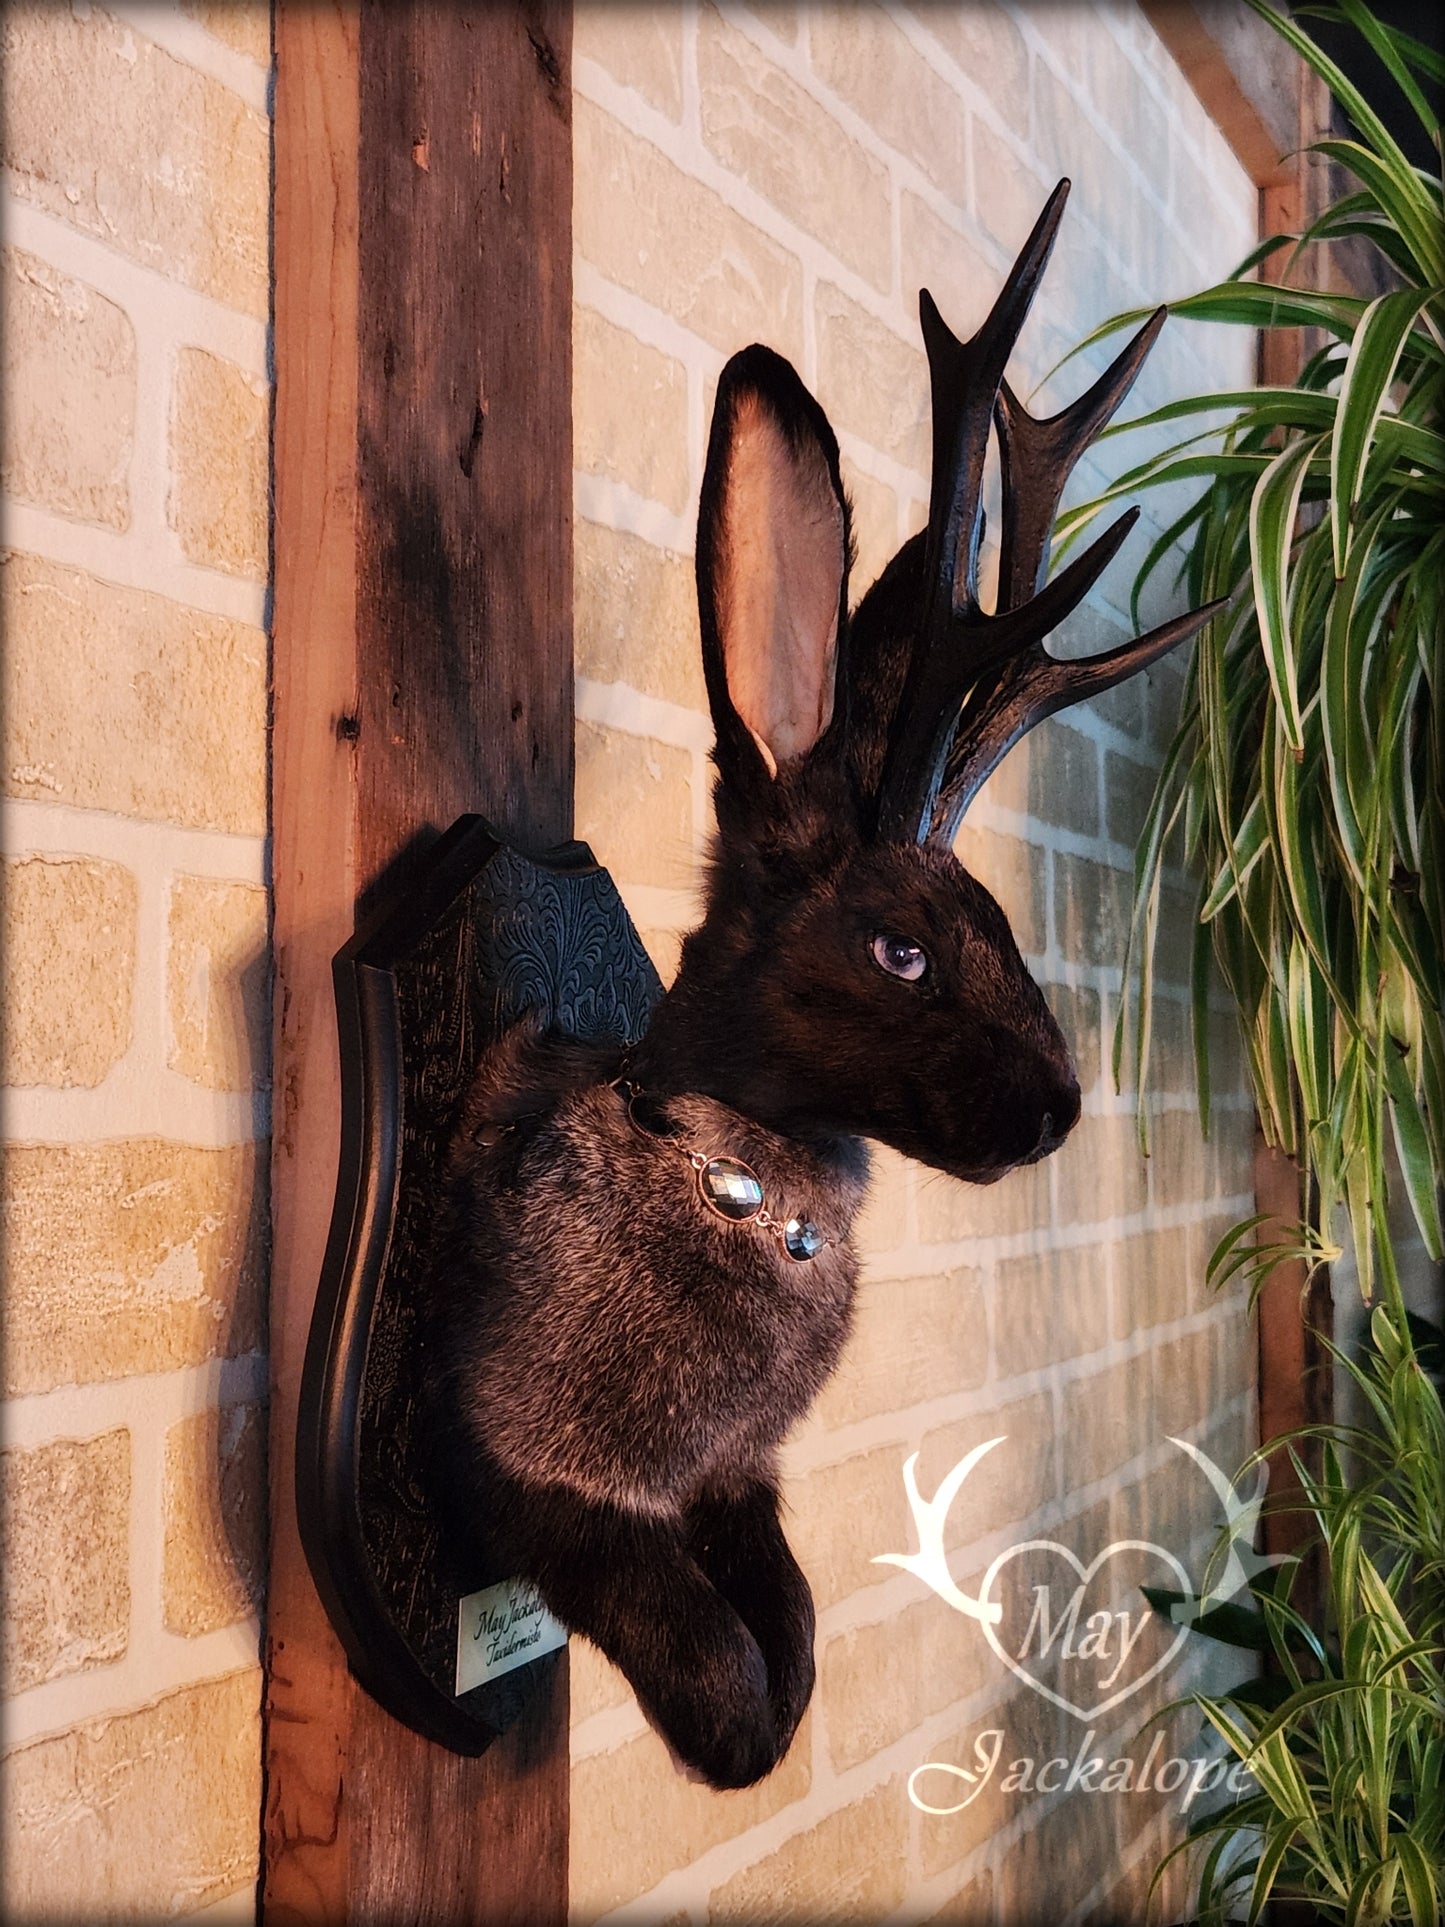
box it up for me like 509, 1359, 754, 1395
2, 4, 1254, 1921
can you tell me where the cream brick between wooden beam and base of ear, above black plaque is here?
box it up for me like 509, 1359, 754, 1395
576, 723, 692, 888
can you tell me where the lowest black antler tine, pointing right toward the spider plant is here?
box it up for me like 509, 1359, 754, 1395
927, 593, 1229, 848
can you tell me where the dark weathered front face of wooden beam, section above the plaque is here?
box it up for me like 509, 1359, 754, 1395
358, 0, 572, 881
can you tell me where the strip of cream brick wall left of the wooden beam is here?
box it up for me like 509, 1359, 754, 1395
0, 4, 270, 1919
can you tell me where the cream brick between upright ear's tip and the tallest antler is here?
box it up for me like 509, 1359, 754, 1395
815, 281, 929, 476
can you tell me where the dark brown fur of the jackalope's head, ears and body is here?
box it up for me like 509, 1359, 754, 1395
432, 349, 1079, 1786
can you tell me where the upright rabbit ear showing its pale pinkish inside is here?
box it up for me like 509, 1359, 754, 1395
697, 347, 848, 786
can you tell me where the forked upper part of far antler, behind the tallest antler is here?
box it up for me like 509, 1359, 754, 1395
994, 308, 1168, 609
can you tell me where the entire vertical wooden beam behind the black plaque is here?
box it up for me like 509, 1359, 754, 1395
264, 0, 572, 1923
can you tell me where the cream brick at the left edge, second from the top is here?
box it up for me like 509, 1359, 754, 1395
0, 247, 135, 528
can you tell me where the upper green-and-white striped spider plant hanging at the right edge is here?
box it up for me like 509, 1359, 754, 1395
1058, 0, 1445, 1310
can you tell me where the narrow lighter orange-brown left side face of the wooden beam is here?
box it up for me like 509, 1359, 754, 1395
266, 4, 360, 1923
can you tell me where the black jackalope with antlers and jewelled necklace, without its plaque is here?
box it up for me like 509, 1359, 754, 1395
428, 181, 1208, 1786
